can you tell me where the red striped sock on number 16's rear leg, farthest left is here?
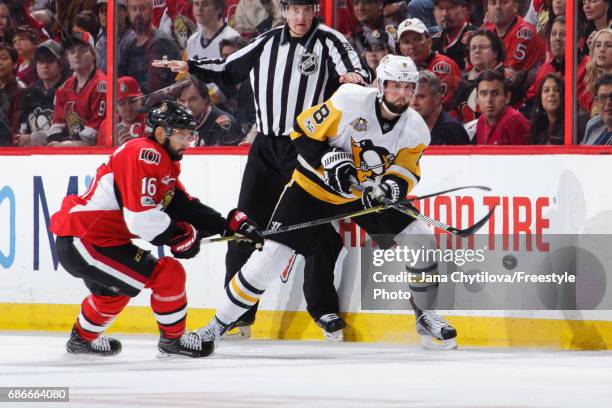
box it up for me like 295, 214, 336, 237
76, 293, 130, 341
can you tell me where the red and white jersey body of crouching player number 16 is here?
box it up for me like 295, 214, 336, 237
50, 138, 184, 246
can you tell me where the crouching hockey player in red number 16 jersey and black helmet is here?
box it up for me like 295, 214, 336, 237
50, 101, 263, 357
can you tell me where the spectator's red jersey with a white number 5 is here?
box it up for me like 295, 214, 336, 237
483, 16, 546, 71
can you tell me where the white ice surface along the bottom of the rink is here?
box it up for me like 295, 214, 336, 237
0, 332, 612, 408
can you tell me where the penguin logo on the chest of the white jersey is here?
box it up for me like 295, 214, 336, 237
351, 139, 395, 181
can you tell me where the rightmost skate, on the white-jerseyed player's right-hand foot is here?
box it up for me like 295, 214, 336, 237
416, 310, 457, 350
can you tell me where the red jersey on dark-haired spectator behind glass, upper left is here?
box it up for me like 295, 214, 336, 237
51, 69, 106, 140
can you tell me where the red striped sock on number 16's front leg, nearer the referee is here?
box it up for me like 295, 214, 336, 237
147, 257, 187, 339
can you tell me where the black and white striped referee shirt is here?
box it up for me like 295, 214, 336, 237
189, 21, 369, 136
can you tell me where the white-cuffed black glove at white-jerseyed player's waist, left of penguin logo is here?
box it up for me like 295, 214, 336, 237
321, 147, 357, 198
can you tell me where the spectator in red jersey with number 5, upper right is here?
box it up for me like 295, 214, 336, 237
483, 0, 545, 83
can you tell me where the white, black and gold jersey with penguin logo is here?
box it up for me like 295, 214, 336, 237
291, 84, 430, 204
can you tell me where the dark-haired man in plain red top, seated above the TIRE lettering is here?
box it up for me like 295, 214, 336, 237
475, 70, 530, 145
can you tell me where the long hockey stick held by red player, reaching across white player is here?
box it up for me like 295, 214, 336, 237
200, 186, 491, 244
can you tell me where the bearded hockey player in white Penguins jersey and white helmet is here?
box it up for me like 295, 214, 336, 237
196, 55, 457, 348
